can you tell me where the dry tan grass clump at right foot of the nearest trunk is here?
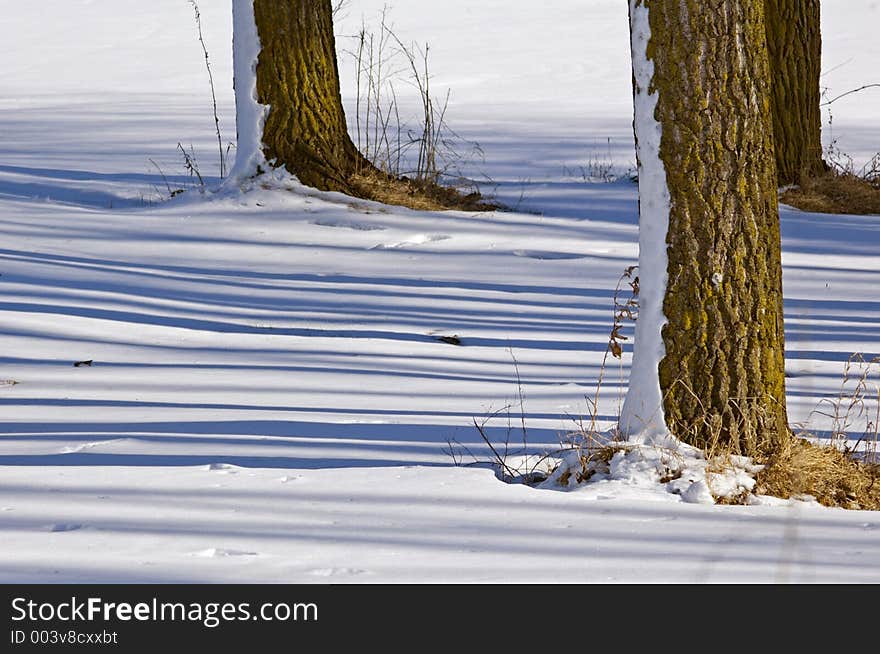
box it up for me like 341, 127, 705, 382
755, 438, 880, 511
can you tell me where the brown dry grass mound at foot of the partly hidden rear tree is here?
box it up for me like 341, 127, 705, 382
779, 170, 880, 215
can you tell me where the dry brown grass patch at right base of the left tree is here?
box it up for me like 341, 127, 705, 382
351, 172, 503, 211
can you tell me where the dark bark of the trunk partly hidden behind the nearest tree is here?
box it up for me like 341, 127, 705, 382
764, 0, 824, 186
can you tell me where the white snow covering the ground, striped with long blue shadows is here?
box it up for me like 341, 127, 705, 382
0, 0, 880, 583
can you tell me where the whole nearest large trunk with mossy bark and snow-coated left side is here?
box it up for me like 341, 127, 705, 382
621, 0, 790, 454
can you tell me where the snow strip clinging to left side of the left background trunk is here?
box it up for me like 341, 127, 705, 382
227, 0, 269, 185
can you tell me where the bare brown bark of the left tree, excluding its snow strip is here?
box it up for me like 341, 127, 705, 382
254, 0, 372, 195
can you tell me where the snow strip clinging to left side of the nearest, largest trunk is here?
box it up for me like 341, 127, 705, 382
620, 0, 670, 441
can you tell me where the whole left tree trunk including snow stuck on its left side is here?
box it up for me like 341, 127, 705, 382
233, 0, 374, 195
